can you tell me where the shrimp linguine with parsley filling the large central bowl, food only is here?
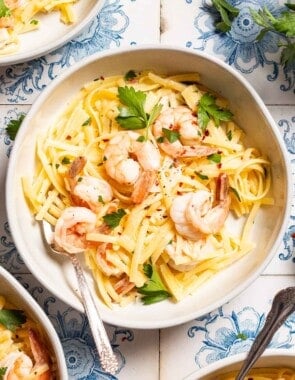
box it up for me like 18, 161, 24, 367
22, 70, 273, 307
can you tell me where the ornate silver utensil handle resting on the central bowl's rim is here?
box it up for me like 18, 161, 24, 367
69, 254, 118, 375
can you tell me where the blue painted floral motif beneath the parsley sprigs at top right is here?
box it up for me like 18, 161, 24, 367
186, 0, 295, 91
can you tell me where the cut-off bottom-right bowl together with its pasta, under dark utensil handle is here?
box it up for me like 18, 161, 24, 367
184, 349, 295, 380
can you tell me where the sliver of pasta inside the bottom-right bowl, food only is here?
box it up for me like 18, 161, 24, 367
214, 367, 295, 380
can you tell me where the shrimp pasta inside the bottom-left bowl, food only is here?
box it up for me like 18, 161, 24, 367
0, 295, 56, 380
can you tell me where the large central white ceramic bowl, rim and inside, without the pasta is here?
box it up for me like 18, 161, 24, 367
6, 46, 291, 329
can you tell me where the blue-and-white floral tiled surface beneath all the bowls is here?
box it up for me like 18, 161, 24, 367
0, 0, 295, 380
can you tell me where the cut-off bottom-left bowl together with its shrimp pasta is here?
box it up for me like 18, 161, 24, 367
0, 266, 68, 380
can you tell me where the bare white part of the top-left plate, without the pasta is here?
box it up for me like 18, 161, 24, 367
0, 0, 103, 66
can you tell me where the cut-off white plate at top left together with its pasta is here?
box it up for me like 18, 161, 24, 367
0, 0, 103, 66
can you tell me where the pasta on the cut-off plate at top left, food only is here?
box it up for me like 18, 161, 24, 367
0, 0, 77, 58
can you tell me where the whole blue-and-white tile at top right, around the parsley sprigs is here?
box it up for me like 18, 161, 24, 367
161, 0, 295, 104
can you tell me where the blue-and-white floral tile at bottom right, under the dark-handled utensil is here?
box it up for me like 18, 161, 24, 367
160, 276, 295, 380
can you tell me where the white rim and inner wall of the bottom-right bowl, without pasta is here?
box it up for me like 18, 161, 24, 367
183, 349, 295, 380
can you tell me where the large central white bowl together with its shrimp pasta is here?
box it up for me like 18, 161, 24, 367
6, 46, 291, 328
